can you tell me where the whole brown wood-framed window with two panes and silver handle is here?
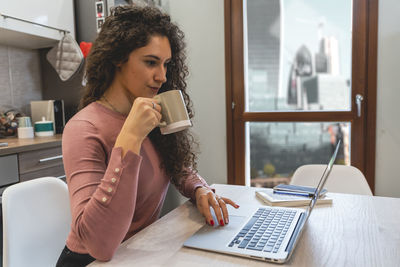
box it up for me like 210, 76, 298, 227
225, 0, 377, 191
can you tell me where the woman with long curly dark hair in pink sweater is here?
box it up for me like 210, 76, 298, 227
57, 6, 238, 266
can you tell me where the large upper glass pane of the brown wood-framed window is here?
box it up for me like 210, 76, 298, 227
243, 0, 352, 112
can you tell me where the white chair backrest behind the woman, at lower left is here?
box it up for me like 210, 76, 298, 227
2, 177, 71, 267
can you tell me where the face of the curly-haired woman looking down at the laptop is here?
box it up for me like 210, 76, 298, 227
114, 35, 171, 100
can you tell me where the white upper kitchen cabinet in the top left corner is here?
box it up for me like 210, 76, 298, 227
0, 0, 75, 49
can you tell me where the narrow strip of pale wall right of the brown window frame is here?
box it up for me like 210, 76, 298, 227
375, 0, 400, 197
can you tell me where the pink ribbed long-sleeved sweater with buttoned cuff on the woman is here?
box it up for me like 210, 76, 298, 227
62, 102, 208, 261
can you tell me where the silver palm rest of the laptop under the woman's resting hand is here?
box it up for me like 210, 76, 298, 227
184, 215, 246, 248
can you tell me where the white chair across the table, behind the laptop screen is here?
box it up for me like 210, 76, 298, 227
290, 164, 372, 196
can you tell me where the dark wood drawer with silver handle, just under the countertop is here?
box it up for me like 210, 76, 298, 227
18, 146, 63, 175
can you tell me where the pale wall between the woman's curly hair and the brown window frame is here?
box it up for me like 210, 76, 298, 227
164, 0, 227, 213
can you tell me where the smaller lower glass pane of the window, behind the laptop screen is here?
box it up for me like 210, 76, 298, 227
246, 122, 351, 187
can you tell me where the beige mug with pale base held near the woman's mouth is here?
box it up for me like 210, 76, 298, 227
154, 90, 192, 134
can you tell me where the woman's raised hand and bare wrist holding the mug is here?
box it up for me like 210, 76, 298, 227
115, 97, 161, 155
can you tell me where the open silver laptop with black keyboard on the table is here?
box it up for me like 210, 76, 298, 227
183, 140, 341, 263
